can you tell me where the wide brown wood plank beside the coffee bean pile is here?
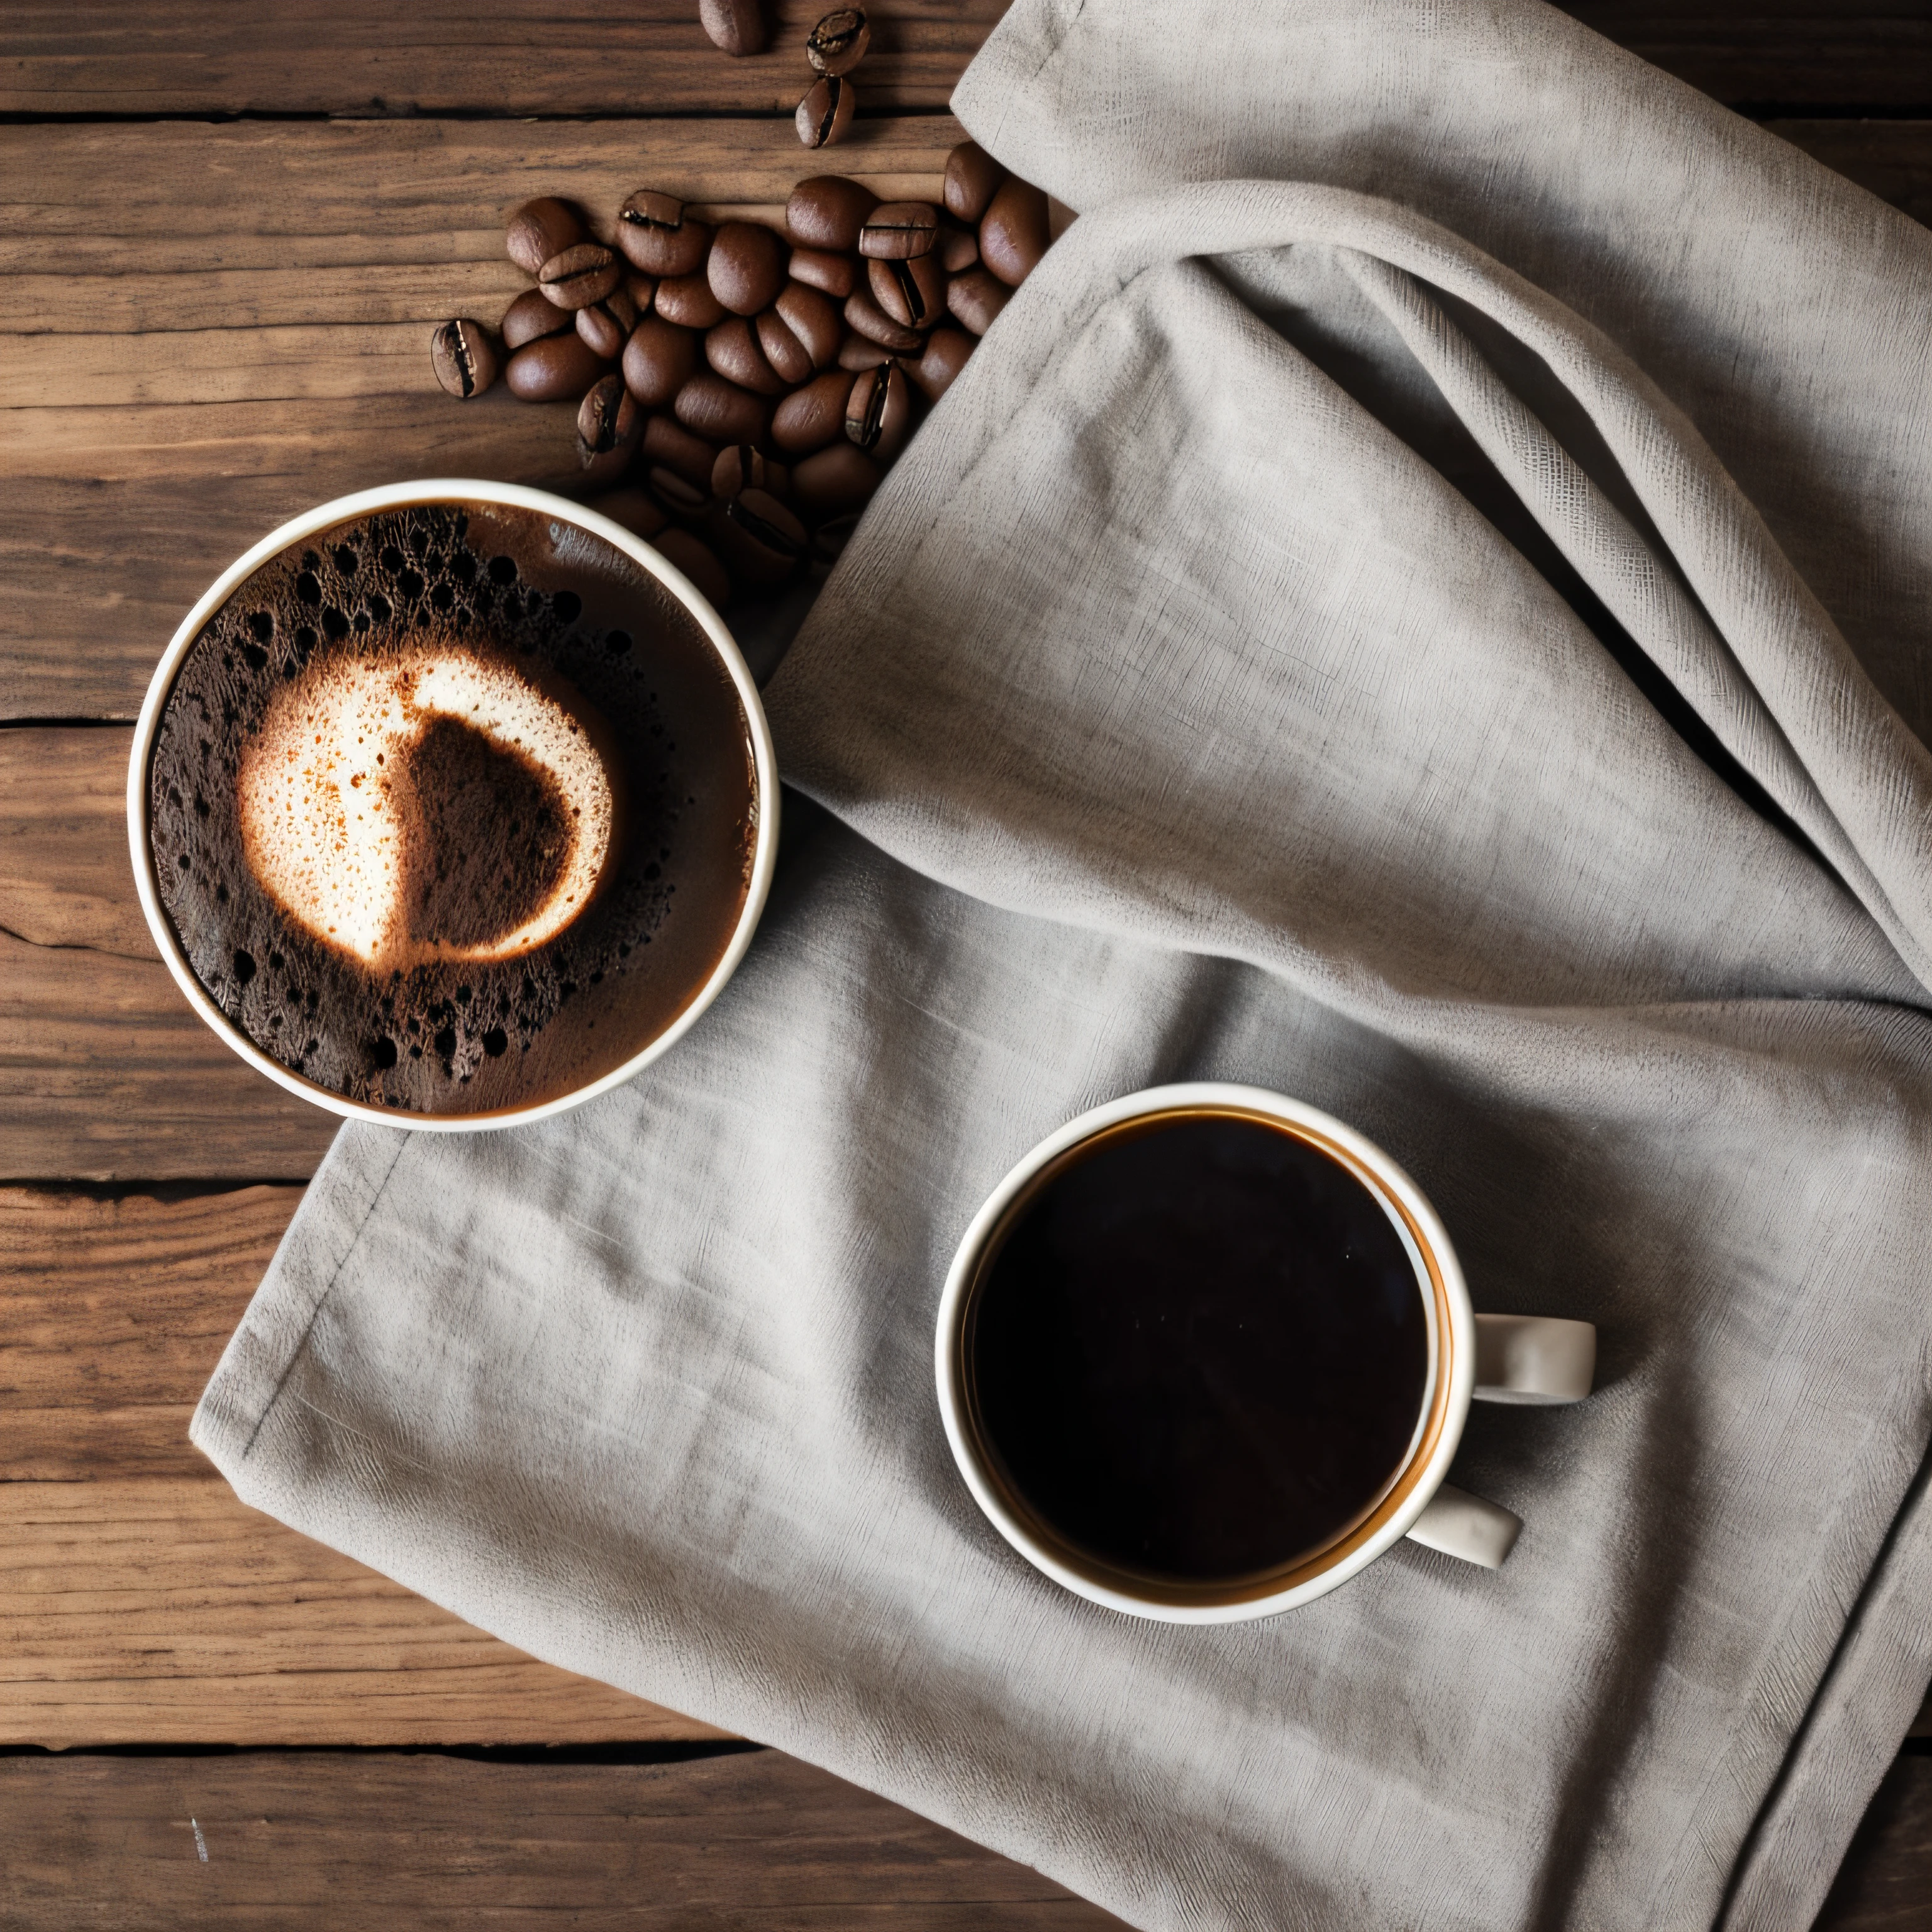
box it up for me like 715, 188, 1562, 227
0, 114, 960, 719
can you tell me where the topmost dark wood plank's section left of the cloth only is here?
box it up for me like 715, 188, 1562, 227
0, 0, 1004, 117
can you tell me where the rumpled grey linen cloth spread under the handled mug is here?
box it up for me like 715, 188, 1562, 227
193, 0, 1932, 1932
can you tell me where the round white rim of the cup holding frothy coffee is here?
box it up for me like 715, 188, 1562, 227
128, 477, 779, 1134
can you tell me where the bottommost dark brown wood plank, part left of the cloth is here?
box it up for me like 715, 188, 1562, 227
0, 1750, 1121, 1932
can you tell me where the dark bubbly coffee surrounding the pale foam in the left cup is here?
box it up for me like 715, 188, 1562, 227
149, 504, 757, 1113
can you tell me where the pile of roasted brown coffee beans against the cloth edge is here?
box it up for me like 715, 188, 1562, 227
431, 141, 1049, 605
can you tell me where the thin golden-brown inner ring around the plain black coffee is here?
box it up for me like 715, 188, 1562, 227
952, 1101, 1457, 1609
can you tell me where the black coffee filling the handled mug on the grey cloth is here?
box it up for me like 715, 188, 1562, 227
964, 1107, 1430, 1584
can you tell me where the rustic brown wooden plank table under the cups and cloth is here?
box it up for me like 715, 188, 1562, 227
0, 0, 1932, 1928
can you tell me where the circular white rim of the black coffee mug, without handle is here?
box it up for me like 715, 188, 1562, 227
933, 1080, 1476, 1623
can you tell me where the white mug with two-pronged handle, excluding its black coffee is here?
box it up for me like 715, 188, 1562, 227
933, 1082, 1596, 1623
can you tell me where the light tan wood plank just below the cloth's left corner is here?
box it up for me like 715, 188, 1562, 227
0, 1476, 719, 1754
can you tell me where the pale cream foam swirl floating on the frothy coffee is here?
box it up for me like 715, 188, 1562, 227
236, 645, 614, 968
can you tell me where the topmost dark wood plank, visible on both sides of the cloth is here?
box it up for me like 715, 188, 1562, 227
0, 0, 1932, 114
